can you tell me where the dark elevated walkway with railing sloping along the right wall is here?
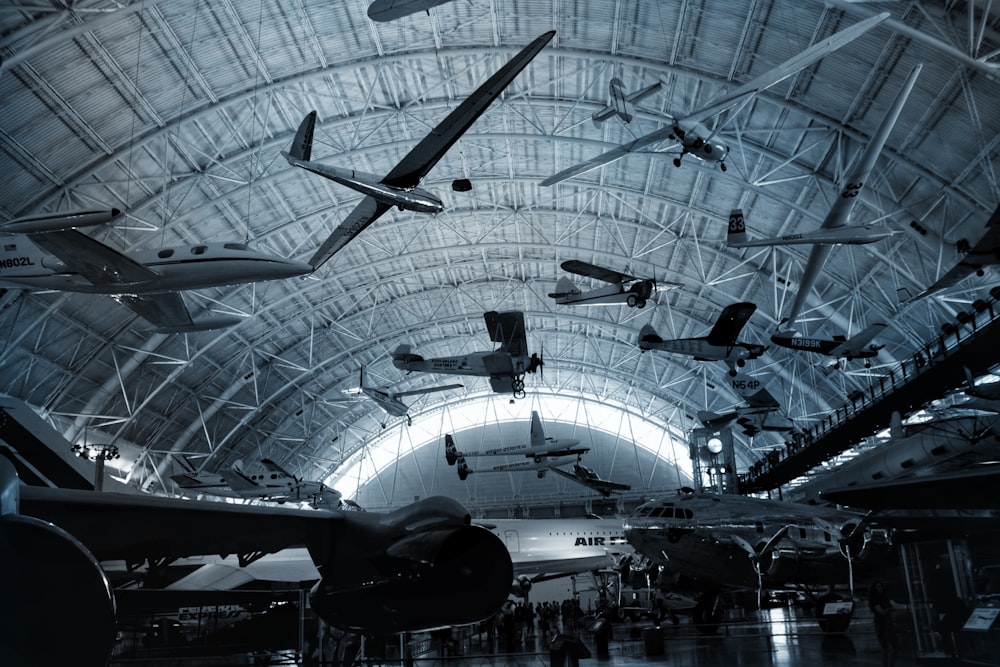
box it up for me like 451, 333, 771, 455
739, 287, 1000, 494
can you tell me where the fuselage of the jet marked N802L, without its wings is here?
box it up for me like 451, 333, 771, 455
0, 237, 313, 294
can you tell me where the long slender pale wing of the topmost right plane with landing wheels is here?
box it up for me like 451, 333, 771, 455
541, 12, 889, 185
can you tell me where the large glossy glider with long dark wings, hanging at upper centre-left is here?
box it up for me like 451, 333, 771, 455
284, 30, 555, 269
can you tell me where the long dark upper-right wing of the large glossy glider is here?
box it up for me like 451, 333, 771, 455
382, 30, 556, 188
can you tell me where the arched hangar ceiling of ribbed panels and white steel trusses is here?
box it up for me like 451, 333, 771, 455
0, 0, 1000, 505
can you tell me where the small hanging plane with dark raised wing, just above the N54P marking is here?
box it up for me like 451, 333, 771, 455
639, 302, 767, 377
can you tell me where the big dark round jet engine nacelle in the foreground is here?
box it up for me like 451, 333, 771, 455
309, 498, 514, 633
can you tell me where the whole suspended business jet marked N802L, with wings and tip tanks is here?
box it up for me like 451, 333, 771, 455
0, 209, 313, 333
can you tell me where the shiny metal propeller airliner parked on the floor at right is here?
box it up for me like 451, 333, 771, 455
625, 493, 891, 634
